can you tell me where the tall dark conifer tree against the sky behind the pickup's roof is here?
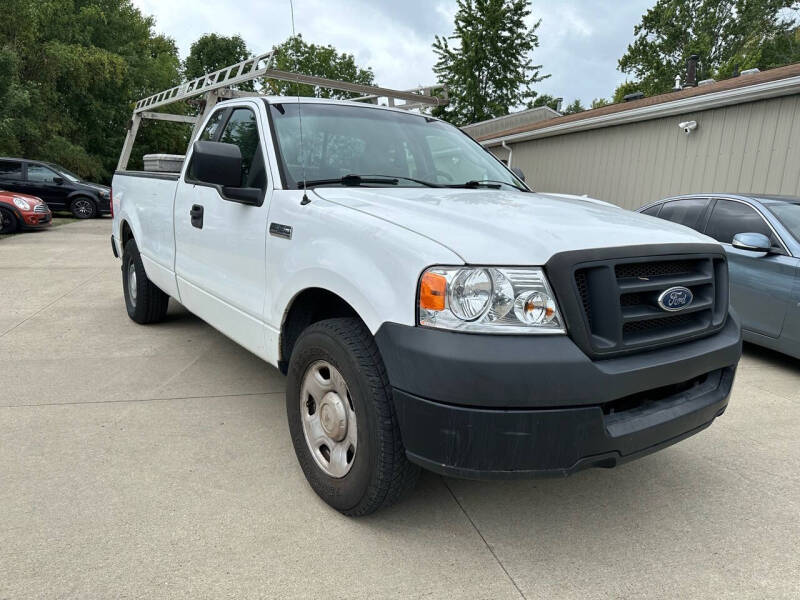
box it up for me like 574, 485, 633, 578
433, 0, 549, 125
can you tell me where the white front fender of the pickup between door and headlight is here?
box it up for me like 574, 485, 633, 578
265, 192, 463, 333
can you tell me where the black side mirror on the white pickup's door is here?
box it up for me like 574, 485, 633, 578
188, 142, 264, 206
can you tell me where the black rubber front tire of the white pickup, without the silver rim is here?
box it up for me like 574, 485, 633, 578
286, 318, 419, 516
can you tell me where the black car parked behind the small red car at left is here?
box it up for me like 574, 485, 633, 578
0, 158, 111, 219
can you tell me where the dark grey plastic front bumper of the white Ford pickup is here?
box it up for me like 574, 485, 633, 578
376, 316, 742, 479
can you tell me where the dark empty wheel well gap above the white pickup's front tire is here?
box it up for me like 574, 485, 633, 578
278, 288, 360, 375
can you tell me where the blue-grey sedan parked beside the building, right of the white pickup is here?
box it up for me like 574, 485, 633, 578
639, 194, 800, 358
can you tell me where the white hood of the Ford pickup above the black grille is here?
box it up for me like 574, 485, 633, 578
314, 187, 716, 265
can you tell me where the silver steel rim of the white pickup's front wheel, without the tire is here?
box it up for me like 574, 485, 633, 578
299, 360, 358, 478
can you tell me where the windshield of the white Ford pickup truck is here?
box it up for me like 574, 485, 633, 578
269, 103, 528, 191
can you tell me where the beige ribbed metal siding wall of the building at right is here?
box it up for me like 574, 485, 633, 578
500, 95, 800, 209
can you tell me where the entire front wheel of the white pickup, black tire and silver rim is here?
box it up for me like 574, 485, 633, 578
286, 318, 419, 516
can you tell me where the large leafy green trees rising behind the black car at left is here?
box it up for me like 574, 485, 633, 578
0, 0, 180, 181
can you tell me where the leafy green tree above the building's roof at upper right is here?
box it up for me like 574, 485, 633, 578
619, 0, 800, 96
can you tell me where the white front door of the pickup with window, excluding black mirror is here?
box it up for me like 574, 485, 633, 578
174, 104, 272, 357
